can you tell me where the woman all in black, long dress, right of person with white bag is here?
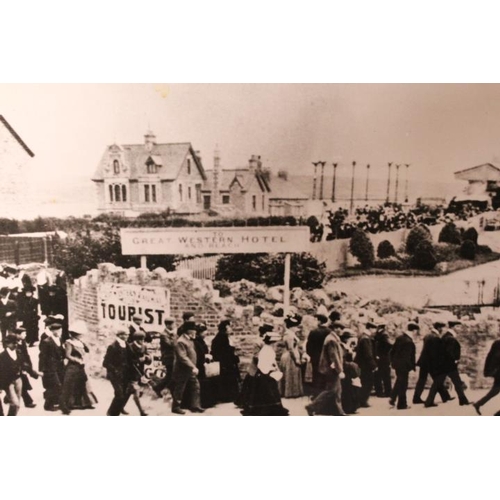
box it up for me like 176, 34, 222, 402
212, 319, 240, 403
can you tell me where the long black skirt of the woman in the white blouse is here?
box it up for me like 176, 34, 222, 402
241, 371, 289, 416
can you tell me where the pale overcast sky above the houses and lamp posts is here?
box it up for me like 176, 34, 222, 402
0, 84, 500, 207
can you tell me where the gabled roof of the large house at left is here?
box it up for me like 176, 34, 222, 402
92, 142, 206, 181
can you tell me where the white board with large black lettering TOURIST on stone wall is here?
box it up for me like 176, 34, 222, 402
97, 283, 170, 332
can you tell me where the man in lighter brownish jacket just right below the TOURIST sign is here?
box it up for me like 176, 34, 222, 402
172, 321, 205, 415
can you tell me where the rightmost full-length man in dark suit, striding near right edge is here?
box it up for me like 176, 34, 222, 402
425, 321, 469, 408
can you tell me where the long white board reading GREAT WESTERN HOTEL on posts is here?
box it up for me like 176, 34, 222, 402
121, 226, 310, 255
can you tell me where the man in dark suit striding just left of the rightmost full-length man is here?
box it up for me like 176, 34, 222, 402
413, 321, 454, 404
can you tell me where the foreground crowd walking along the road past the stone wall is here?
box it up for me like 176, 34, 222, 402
0, 278, 500, 416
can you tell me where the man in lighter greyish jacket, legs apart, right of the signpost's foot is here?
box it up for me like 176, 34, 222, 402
306, 321, 345, 416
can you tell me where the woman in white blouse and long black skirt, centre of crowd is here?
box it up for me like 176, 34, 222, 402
241, 331, 288, 416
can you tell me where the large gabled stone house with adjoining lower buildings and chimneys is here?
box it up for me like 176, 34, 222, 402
92, 132, 308, 217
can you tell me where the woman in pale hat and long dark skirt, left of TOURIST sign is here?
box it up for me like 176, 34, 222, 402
60, 320, 97, 415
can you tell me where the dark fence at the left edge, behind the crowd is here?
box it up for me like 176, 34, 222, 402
0, 236, 52, 265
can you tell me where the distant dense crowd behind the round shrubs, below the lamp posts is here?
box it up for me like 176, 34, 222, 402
312, 201, 486, 241
